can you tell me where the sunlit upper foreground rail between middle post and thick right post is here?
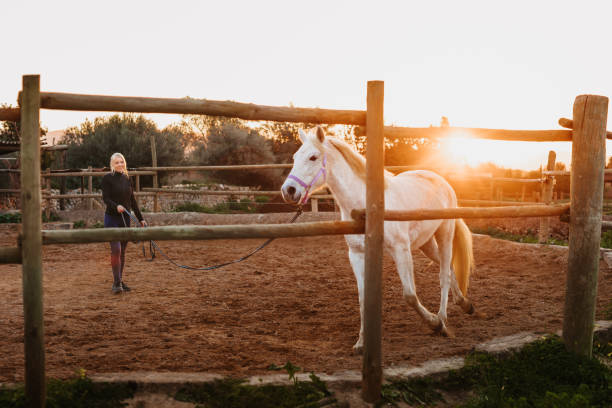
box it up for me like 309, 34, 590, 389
355, 126, 572, 142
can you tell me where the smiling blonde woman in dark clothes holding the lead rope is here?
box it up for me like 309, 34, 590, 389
102, 153, 147, 294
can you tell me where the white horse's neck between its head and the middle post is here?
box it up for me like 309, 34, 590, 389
327, 153, 365, 219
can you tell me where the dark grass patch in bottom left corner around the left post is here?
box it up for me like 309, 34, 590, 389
0, 370, 136, 408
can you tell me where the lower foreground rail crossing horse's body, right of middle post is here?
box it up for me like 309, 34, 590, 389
351, 204, 570, 221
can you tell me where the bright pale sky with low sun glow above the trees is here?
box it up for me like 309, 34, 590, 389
0, 0, 612, 169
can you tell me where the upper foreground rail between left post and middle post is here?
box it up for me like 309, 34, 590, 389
29, 92, 366, 125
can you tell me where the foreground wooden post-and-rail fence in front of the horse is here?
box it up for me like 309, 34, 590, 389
0, 75, 608, 407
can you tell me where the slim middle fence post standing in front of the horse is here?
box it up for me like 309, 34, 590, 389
362, 81, 385, 402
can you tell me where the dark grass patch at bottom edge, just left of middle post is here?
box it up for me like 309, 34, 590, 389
174, 362, 337, 408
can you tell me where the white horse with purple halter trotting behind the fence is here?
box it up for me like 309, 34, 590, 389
281, 128, 474, 352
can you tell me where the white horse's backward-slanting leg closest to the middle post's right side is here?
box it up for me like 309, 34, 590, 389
391, 245, 447, 334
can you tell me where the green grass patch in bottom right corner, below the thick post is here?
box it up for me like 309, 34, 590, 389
379, 336, 612, 408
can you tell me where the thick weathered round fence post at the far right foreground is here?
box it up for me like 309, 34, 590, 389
563, 95, 608, 357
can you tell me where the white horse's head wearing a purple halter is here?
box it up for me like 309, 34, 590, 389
281, 127, 327, 204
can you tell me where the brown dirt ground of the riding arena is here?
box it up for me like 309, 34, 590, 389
0, 215, 612, 383
